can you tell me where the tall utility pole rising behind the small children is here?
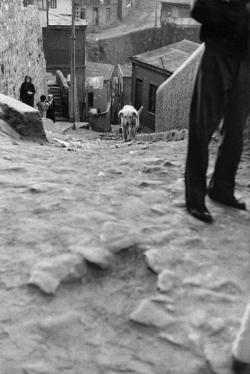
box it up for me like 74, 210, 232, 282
70, 0, 76, 130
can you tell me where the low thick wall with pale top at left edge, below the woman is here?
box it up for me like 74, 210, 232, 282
0, 94, 46, 142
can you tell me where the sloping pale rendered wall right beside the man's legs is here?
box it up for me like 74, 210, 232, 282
155, 45, 204, 132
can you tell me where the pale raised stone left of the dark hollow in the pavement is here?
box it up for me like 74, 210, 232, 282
29, 254, 86, 294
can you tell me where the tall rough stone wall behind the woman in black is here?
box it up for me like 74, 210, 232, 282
0, 0, 47, 103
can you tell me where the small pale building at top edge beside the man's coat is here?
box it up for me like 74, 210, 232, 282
160, 0, 197, 26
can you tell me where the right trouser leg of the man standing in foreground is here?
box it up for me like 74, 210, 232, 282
210, 61, 250, 199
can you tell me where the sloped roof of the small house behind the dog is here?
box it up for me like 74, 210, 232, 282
132, 39, 200, 73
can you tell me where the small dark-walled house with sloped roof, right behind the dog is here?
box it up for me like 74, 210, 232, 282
131, 40, 199, 131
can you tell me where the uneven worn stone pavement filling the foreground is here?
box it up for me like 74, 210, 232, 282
0, 128, 250, 374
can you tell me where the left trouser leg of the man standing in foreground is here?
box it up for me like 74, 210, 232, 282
185, 47, 241, 208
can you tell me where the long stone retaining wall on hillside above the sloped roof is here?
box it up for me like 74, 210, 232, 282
86, 24, 199, 65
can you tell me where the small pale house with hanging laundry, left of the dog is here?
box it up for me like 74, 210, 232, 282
85, 62, 114, 132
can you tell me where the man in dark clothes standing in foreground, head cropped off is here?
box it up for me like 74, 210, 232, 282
185, 0, 250, 223
